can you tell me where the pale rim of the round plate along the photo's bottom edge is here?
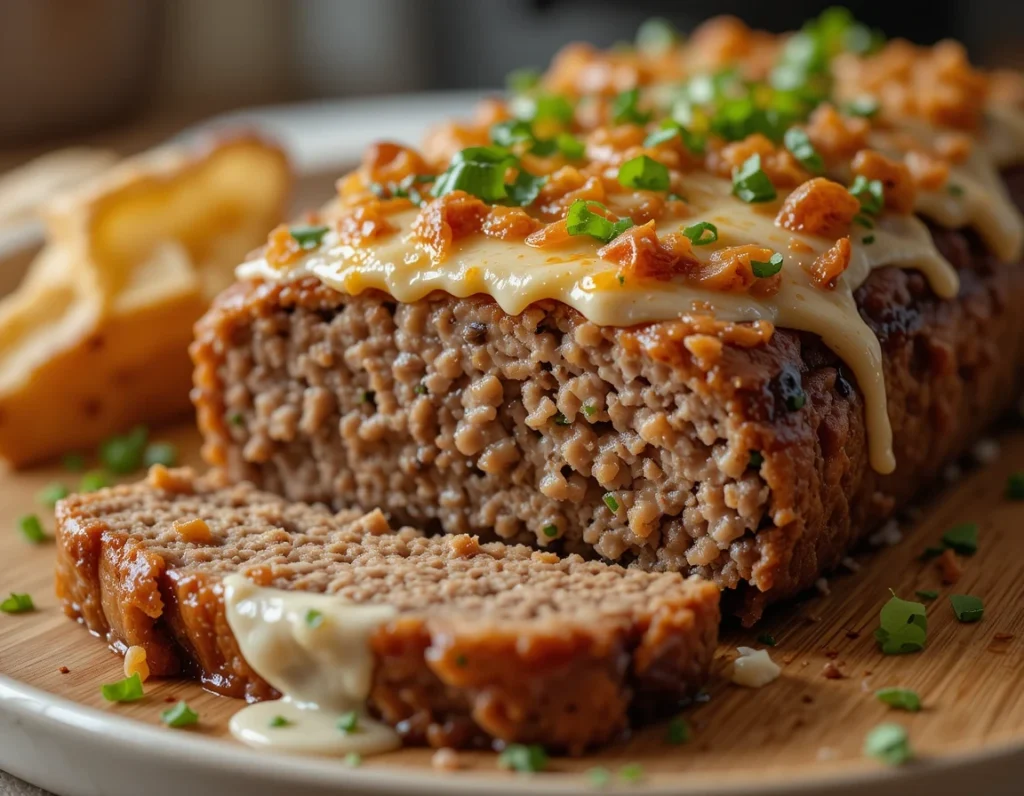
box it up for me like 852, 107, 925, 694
0, 676, 1024, 796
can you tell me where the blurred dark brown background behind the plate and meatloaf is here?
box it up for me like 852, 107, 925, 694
0, 0, 1024, 156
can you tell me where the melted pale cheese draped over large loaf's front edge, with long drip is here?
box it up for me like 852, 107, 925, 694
239, 172, 958, 472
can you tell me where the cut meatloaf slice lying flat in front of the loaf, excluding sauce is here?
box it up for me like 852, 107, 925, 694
51, 467, 719, 751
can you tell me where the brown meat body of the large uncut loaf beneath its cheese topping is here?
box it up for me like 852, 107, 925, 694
193, 171, 1024, 622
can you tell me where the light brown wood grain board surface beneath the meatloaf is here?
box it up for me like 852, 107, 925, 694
0, 425, 1024, 784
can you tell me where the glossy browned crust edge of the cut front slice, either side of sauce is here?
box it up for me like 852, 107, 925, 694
56, 477, 720, 753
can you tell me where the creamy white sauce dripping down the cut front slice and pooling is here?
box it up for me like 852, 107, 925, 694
224, 575, 401, 755
